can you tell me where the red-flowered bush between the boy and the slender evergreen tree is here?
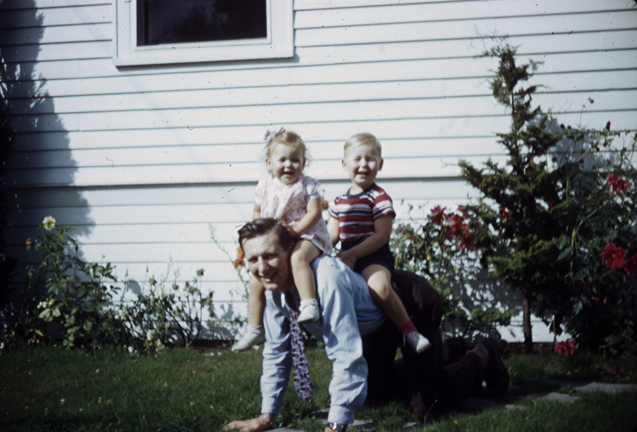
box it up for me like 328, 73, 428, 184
392, 206, 515, 338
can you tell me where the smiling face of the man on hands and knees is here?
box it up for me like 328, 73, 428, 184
243, 233, 292, 292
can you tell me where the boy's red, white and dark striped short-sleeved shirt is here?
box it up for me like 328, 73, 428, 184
328, 183, 396, 241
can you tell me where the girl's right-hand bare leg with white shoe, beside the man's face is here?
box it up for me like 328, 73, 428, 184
290, 240, 321, 323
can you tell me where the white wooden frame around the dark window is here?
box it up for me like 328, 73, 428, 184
113, 0, 294, 67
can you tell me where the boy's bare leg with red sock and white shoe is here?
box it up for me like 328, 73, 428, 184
361, 264, 431, 352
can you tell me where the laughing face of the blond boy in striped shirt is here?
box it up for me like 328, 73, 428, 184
342, 144, 383, 193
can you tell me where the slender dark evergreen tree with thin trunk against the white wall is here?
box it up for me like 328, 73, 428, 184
460, 45, 565, 351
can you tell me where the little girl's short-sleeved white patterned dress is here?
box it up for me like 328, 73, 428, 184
254, 175, 332, 255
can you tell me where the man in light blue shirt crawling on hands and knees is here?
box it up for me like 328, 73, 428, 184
225, 219, 508, 432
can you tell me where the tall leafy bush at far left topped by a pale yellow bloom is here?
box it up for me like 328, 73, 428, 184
21, 216, 129, 348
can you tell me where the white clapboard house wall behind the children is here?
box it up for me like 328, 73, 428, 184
0, 0, 637, 338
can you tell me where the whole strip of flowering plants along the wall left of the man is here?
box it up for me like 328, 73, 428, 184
2, 216, 214, 353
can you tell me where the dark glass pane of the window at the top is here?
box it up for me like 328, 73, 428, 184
137, 0, 267, 46
